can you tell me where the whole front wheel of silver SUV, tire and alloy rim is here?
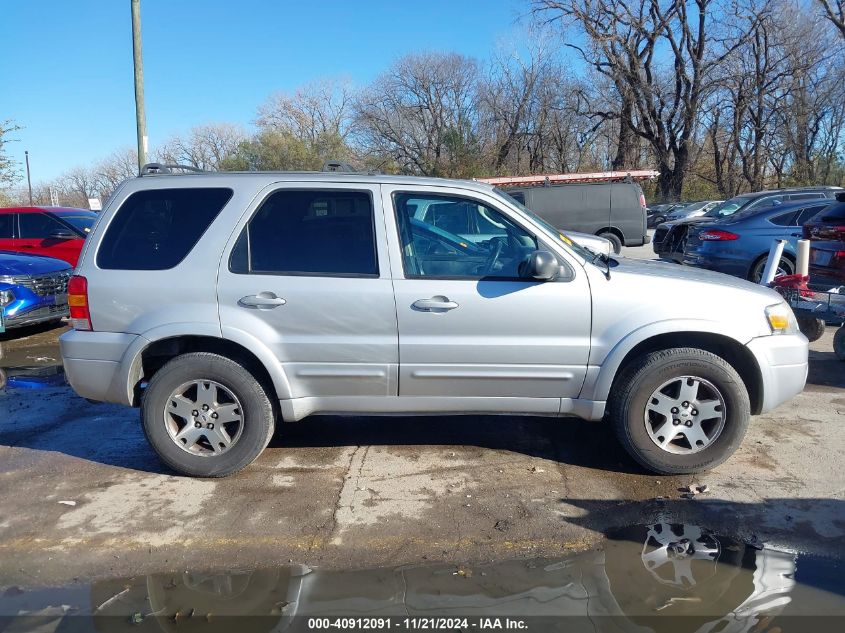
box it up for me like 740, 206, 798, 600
608, 348, 751, 475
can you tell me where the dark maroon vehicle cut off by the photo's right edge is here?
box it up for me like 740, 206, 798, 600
803, 193, 845, 286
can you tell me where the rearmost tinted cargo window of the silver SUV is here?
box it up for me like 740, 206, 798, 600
97, 188, 232, 270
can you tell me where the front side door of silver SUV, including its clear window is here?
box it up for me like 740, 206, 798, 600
382, 186, 591, 402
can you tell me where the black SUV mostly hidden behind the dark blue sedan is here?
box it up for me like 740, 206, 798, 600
652, 187, 842, 263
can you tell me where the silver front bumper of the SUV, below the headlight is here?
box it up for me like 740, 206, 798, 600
747, 334, 809, 413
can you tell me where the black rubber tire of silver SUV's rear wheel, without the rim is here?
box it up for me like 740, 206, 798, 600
141, 352, 275, 477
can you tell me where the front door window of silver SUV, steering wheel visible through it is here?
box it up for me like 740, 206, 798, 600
393, 193, 538, 279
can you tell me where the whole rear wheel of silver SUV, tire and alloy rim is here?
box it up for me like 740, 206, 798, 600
141, 352, 274, 477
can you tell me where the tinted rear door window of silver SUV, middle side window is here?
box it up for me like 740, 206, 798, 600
229, 189, 378, 277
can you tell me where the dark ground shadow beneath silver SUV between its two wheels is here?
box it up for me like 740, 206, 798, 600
270, 415, 645, 474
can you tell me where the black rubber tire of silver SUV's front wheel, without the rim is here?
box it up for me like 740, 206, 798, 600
608, 347, 751, 475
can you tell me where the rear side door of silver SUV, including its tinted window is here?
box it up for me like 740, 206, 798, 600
218, 183, 399, 398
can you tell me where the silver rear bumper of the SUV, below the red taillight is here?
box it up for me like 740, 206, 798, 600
59, 330, 138, 405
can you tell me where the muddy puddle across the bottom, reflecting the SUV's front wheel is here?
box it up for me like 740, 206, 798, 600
0, 523, 845, 633
